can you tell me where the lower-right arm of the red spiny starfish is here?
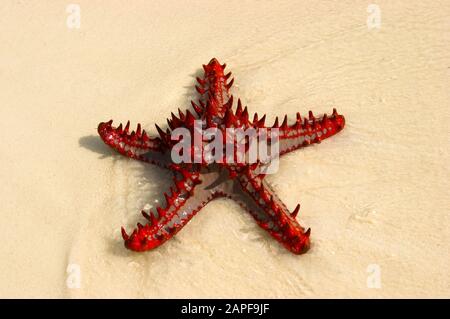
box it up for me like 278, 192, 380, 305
226, 170, 310, 254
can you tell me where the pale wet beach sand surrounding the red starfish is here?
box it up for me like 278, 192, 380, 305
0, 0, 450, 298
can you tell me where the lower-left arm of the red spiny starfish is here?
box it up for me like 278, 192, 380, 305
122, 168, 212, 251
